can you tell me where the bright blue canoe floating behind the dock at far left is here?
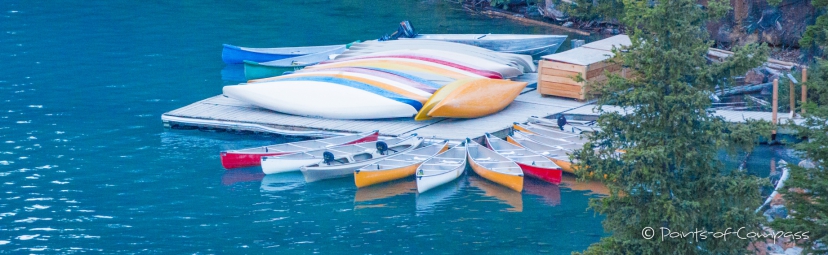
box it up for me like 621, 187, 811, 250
221, 44, 346, 64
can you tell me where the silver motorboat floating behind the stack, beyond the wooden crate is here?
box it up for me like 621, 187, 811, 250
400, 34, 566, 55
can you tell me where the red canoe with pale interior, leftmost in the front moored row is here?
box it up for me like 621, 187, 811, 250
221, 130, 379, 169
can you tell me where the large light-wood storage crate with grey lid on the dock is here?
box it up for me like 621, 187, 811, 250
538, 48, 626, 100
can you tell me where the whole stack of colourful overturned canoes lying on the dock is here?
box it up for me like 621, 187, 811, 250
223, 41, 535, 120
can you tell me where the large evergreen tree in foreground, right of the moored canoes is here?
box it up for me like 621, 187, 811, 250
573, 0, 767, 254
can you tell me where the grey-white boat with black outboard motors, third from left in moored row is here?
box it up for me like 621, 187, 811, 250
299, 134, 423, 182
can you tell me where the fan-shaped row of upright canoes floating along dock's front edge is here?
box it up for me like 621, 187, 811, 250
221, 123, 584, 193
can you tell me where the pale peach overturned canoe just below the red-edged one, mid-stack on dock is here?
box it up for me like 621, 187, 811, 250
307, 58, 492, 79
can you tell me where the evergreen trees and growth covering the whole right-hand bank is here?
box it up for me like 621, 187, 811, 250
452, 0, 828, 254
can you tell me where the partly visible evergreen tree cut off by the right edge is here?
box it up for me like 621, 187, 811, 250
772, 0, 828, 247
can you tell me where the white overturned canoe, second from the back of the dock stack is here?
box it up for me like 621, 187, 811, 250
325, 49, 523, 78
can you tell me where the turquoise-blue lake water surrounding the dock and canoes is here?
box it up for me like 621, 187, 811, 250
0, 0, 796, 254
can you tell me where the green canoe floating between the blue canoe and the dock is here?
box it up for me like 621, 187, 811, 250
239, 45, 346, 80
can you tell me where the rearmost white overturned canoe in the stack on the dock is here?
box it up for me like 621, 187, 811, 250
342, 40, 537, 72
